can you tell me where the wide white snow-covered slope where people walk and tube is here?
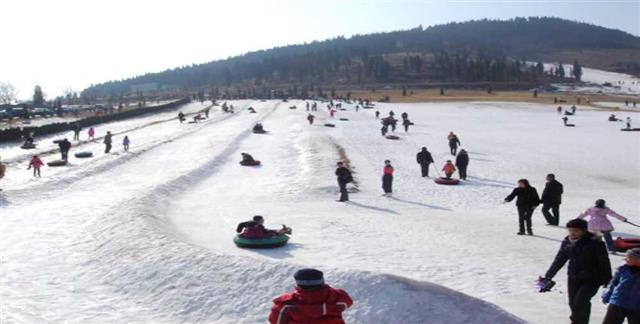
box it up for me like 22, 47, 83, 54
0, 101, 640, 323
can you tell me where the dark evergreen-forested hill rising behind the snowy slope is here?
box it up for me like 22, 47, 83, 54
83, 17, 640, 97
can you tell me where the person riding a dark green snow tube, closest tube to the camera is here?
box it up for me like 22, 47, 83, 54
233, 215, 292, 249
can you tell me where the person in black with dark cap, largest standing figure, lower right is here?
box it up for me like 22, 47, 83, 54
541, 219, 612, 324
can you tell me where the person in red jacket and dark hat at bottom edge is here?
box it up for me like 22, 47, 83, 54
269, 269, 353, 324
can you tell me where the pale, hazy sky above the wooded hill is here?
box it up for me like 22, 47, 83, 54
0, 0, 640, 98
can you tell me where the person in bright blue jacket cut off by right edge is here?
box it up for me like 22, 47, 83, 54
602, 248, 640, 324
